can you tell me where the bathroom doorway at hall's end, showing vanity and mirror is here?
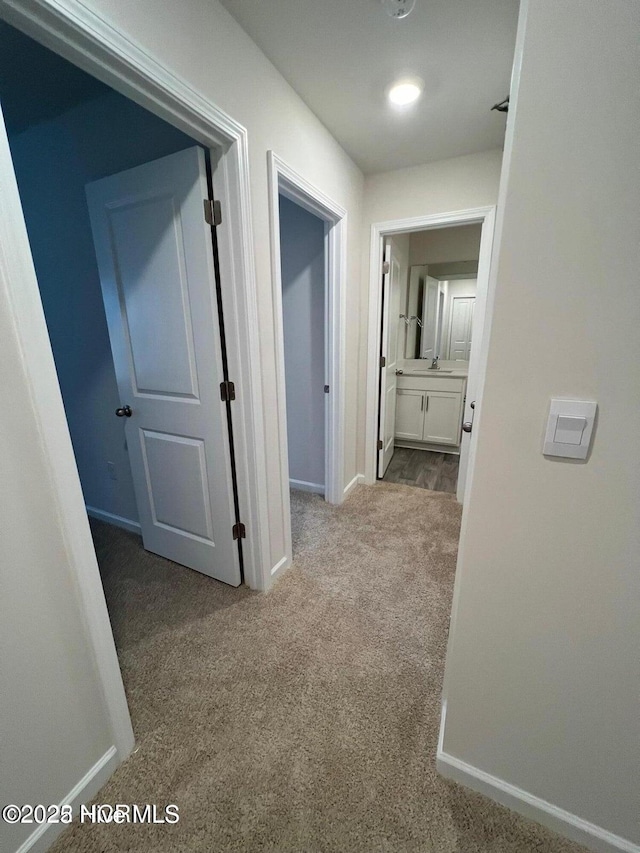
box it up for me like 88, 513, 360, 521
365, 208, 495, 503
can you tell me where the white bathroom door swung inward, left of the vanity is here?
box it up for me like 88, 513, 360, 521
378, 240, 401, 477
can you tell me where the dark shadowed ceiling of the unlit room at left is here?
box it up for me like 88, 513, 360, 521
0, 21, 110, 136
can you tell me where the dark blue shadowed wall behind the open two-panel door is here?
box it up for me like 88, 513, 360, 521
7, 88, 195, 522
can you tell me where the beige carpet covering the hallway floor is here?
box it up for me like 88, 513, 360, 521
54, 484, 582, 853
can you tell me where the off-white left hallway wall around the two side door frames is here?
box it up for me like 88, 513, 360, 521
51, 0, 364, 565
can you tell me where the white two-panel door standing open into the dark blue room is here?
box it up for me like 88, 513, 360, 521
86, 146, 240, 586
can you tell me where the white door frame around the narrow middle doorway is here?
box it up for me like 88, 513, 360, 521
267, 151, 347, 567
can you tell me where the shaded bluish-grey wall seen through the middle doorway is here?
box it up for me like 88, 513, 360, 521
280, 196, 326, 487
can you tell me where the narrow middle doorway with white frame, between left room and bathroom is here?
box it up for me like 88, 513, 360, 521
268, 151, 346, 573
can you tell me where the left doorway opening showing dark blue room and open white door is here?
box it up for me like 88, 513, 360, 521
0, 24, 241, 585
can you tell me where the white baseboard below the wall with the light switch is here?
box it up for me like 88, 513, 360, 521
436, 746, 640, 853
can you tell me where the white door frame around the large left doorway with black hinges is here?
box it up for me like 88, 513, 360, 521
0, 0, 271, 759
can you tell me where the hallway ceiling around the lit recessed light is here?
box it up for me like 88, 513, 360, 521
221, 0, 519, 173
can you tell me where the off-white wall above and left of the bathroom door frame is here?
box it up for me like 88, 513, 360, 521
357, 153, 502, 472
